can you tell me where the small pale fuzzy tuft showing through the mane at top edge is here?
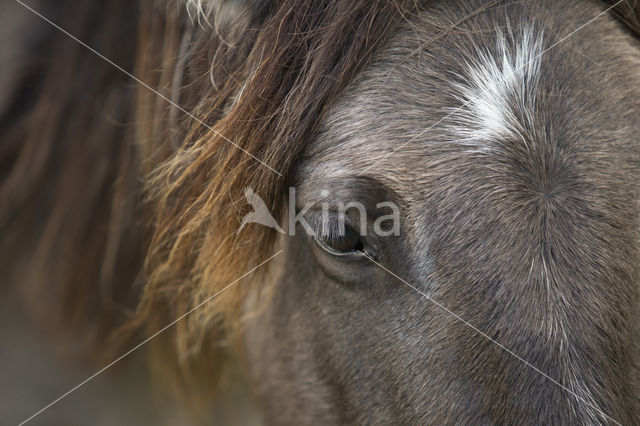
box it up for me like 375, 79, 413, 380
187, 0, 272, 29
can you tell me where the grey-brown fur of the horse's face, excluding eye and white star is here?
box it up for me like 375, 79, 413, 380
245, 0, 640, 424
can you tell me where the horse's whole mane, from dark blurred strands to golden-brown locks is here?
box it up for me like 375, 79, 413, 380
0, 0, 640, 406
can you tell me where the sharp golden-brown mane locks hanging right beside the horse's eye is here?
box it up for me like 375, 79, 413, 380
141, 0, 432, 402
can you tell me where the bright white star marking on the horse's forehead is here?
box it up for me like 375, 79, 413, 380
450, 27, 542, 152
